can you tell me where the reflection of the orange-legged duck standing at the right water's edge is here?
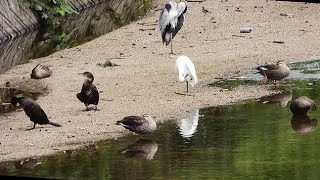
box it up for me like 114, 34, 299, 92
258, 91, 292, 107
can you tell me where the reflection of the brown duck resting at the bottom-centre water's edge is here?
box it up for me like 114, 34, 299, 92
121, 139, 158, 160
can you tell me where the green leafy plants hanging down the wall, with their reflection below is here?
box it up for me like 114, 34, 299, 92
18, 0, 78, 60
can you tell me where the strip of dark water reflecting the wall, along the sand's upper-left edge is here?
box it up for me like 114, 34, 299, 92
0, 0, 151, 74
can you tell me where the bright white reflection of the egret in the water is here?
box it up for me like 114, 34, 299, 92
177, 109, 199, 139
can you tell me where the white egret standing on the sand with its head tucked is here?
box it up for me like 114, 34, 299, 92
175, 55, 198, 92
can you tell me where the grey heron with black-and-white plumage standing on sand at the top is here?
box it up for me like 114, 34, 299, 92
156, 1, 187, 54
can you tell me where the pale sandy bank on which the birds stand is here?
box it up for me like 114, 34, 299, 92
0, 0, 320, 162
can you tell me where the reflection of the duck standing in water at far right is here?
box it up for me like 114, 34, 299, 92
291, 114, 317, 134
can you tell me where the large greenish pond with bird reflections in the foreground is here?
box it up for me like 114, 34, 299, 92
0, 61, 320, 180
